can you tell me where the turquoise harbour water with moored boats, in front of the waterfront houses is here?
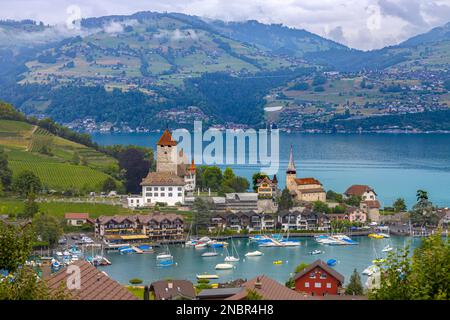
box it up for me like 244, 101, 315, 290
96, 236, 421, 284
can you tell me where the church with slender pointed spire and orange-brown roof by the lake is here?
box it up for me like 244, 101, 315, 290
286, 146, 326, 202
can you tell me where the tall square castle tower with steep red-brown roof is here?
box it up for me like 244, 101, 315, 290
156, 129, 178, 175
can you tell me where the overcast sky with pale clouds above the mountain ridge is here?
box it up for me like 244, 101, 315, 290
0, 0, 450, 50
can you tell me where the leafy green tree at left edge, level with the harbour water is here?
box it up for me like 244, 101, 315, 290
0, 221, 33, 273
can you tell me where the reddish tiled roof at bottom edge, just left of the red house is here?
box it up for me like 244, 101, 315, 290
225, 275, 305, 300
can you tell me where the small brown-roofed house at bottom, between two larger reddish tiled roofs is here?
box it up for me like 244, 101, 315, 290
149, 280, 196, 300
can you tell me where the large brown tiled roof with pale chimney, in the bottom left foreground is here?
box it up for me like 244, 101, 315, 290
46, 260, 138, 300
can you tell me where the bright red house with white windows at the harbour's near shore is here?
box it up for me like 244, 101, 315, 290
294, 260, 344, 296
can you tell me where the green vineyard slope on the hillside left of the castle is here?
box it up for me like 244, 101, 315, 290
0, 120, 121, 190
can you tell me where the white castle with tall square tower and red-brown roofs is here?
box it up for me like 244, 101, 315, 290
128, 129, 196, 208
